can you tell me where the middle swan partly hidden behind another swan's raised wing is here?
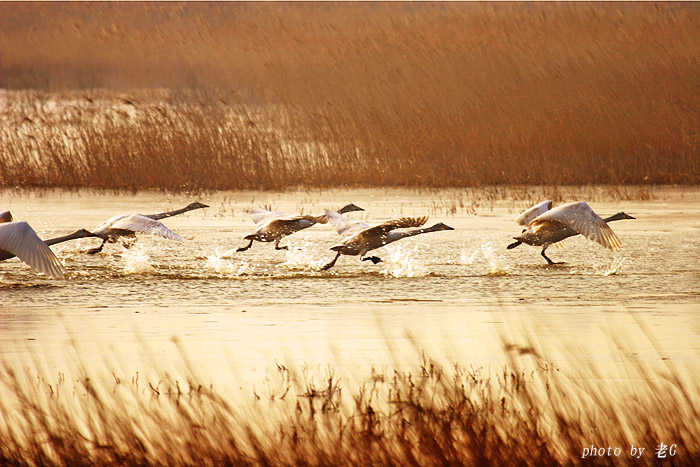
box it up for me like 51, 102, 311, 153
236, 203, 364, 252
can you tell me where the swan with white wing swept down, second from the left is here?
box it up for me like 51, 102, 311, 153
87, 201, 209, 255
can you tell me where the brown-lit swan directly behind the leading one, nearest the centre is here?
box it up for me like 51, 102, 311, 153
321, 216, 454, 271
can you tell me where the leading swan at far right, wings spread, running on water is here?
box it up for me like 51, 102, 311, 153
508, 200, 634, 264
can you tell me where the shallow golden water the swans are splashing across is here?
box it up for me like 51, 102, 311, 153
0, 189, 700, 382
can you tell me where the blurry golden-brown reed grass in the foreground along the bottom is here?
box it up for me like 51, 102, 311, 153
0, 330, 700, 466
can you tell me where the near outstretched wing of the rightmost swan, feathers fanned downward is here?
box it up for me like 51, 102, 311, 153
531, 201, 622, 250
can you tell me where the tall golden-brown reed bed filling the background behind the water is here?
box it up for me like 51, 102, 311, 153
0, 3, 700, 191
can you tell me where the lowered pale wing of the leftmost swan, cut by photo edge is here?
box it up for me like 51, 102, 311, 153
0, 222, 66, 279
